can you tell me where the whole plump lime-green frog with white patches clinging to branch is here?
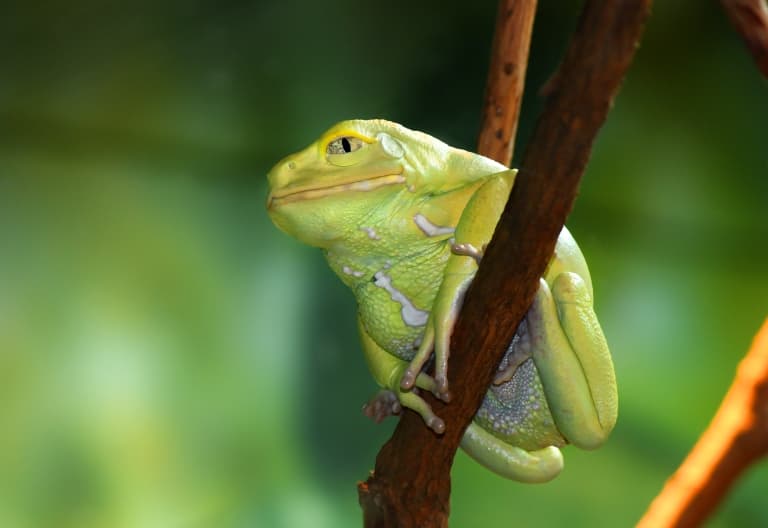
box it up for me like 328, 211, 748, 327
266, 119, 618, 483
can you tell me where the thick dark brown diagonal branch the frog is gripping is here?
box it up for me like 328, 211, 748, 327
359, 0, 651, 527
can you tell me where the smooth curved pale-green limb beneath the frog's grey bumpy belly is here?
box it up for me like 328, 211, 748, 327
461, 423, 563, 483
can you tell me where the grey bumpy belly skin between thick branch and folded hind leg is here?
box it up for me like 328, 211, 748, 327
474, 359, 566, 451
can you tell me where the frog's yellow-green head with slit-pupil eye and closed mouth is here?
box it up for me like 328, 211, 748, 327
267, 119, 504, 247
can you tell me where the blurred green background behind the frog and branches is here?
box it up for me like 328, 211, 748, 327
0, 0, 768, 528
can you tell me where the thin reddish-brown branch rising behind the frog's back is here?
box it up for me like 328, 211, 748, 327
477, 0, 536, 166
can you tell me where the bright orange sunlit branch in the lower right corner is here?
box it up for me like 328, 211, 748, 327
638, 319, 768, 528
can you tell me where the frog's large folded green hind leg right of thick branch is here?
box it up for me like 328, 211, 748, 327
527, 272, 618, 449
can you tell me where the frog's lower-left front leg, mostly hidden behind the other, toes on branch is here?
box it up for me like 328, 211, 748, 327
358, 318, 445, 434
